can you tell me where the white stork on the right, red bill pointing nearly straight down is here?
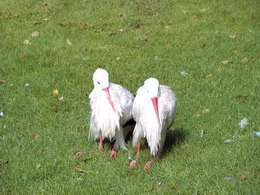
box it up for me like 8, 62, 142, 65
130, 78, 177, 170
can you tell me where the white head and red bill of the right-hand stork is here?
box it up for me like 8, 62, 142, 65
144, 78, 160, 124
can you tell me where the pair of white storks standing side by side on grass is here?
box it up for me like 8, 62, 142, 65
89, 68, 176, 169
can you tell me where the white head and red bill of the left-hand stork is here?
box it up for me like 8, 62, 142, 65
93, 68, 115, 111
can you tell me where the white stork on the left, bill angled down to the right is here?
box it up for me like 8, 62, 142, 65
89, 68, 134, 158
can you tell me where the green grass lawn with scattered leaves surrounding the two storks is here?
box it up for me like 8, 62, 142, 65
0, 0, 260, 195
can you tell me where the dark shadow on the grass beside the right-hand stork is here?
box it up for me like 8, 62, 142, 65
161, 128, 188, 158
